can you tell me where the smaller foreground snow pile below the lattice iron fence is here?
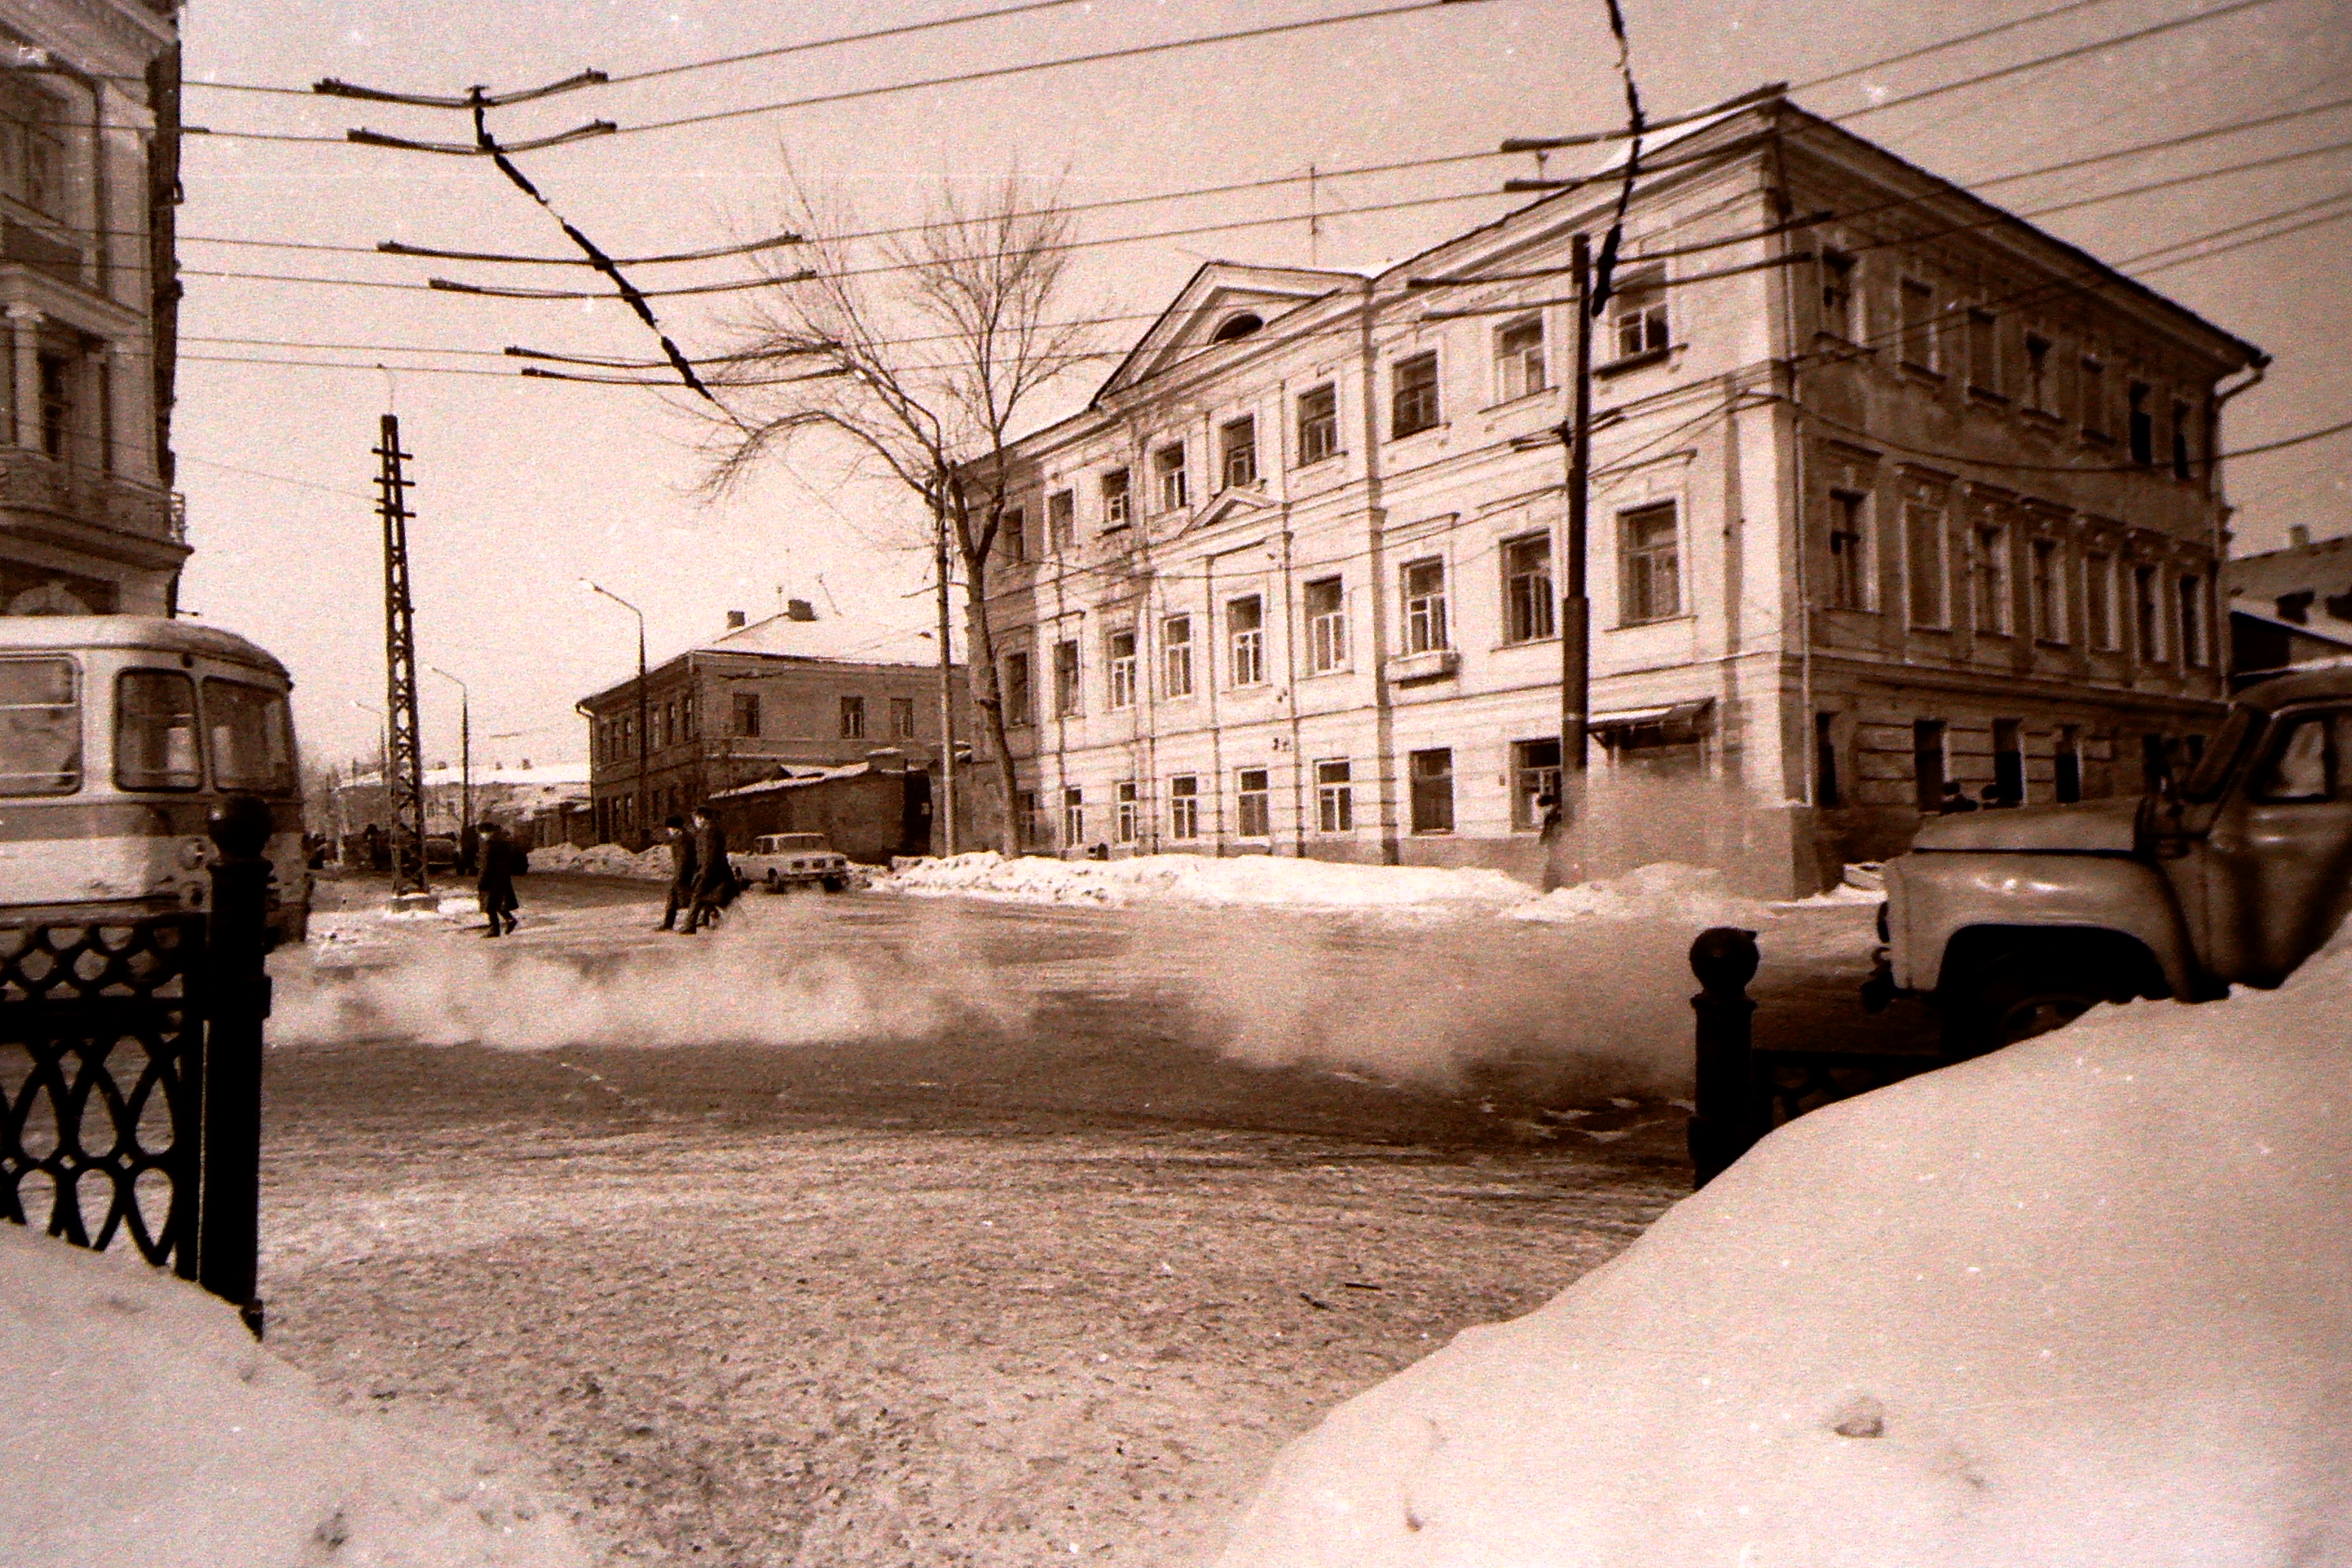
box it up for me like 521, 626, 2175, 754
0, 1225, 595, 1568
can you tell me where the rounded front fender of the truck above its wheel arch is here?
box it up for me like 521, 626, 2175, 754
1889, 853, 2199, 997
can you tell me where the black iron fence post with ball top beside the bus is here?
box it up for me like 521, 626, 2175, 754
195, 795, 273, 1340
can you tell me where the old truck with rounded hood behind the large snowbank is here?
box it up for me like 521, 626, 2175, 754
1863, 668, 2352, 1058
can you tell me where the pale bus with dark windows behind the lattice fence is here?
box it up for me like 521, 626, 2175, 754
0, 616, 311, 942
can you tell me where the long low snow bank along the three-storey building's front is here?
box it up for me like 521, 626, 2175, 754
872, 851, 1529, 910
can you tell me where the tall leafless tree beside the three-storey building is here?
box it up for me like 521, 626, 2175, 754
706, 174, 1098, 853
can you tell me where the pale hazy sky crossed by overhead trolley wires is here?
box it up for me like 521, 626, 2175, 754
174, 0, 2352, 766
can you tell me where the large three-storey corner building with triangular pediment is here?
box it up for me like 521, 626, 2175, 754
969, 99, 2263, 893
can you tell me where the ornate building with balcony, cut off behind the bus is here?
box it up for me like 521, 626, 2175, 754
0, 0, 188, 616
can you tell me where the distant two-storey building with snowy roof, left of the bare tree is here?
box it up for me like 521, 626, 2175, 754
578, 599, 971, 844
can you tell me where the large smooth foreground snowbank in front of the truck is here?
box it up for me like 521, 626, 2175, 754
1226, 942, 2352, 1568
